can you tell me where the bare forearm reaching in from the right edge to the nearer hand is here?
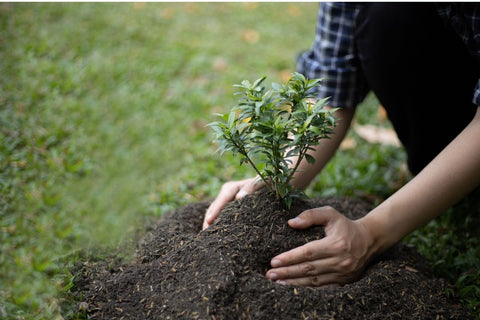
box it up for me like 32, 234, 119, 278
359, 110, 480, 252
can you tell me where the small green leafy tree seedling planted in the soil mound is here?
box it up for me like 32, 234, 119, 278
209, 73, 336, 208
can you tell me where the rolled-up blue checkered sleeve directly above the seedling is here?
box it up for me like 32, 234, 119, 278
297, 2, 368, 108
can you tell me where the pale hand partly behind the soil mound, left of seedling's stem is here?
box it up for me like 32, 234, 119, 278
203, 177, 265, 229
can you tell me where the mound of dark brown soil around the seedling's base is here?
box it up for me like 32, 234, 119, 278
76, 191, 470, 320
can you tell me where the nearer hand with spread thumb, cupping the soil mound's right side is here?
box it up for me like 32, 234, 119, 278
266, 207, 373, 286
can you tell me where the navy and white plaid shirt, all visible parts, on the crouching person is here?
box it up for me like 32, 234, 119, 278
297, 2, 480, 108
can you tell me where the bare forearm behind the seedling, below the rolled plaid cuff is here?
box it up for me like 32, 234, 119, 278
292, 108, 355, 189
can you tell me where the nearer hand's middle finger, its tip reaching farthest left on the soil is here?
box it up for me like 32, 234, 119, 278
266, 258, 338, 280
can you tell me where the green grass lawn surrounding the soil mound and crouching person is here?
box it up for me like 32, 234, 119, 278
0, 3, 480, 319
